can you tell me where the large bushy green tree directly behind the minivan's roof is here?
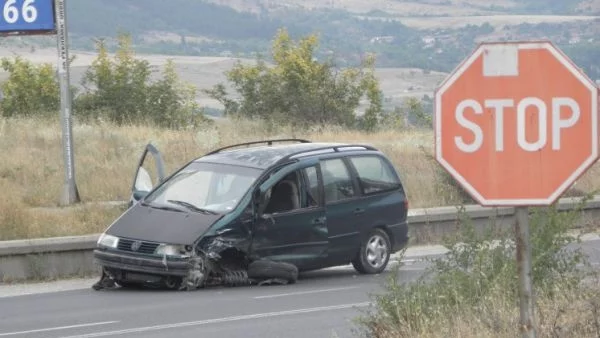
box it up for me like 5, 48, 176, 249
206, 29, 382, 128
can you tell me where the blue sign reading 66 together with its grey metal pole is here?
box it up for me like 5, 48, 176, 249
0, 0, 80, 205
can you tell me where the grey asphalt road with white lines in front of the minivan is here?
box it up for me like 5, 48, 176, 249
0, 238, 600, 338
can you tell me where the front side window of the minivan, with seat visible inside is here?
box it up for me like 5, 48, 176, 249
264, 167, 319, 214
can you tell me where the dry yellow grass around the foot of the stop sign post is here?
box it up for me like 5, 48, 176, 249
358, 280, 600, 338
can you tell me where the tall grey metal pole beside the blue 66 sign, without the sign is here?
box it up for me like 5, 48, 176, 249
54, 0, 80, 205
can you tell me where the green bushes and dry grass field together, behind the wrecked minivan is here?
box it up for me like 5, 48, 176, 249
0, 30, 600, 240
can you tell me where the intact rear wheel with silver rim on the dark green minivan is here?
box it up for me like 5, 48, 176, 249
352, 228, 391, 274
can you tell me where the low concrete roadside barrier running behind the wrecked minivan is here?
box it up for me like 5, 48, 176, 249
0, 196, 600, 283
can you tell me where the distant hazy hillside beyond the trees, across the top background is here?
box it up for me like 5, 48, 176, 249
0, 0, 600, 109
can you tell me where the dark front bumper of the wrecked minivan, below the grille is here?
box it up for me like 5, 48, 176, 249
94, 249, 189, 277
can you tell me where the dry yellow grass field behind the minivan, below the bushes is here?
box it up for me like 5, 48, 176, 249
0, 119, 600, 240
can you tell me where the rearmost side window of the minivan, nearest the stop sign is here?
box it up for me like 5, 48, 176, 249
350, 156, 400, 194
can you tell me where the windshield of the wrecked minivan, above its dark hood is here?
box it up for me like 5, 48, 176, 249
144, 162, 261, 213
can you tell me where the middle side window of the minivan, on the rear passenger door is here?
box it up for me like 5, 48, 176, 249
321, 158, 356, 204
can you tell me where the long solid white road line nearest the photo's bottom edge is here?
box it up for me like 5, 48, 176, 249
55, 302, 371, 338
